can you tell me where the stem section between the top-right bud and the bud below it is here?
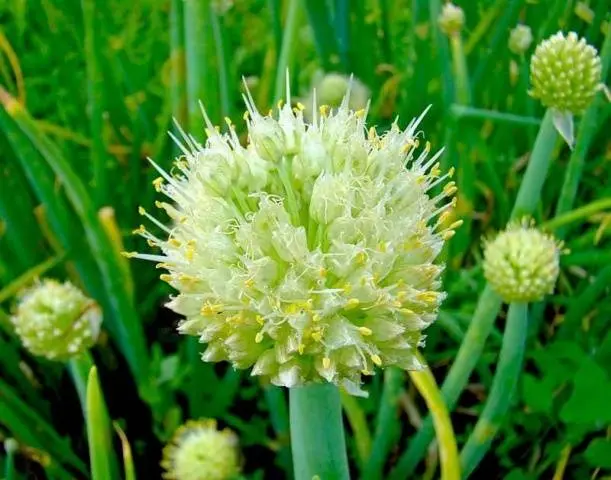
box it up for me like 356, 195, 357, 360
511, 109, 558, 220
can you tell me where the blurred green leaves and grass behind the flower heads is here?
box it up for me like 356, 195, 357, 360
0, 0, 611, 480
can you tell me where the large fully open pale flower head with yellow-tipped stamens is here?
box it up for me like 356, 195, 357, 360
128, 81, 459, 393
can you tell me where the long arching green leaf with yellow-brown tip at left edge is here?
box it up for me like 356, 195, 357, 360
0, 89, 148, 385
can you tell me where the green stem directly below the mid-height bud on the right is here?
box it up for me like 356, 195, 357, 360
460, 303, 528, 478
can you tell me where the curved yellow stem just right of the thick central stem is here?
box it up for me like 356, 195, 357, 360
409, 352, 460, 480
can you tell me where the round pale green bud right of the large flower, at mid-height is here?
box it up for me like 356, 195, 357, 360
484, 222, 562, 303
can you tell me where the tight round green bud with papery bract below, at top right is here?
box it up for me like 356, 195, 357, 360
530, 32, 601, 115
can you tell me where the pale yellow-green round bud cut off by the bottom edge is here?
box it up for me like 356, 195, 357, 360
161, 419, 240, 480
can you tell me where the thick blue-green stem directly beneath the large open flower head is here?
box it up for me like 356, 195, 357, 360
289, 383, 350, 480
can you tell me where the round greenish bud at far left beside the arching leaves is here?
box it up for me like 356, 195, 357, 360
11, 280, 102, 361
